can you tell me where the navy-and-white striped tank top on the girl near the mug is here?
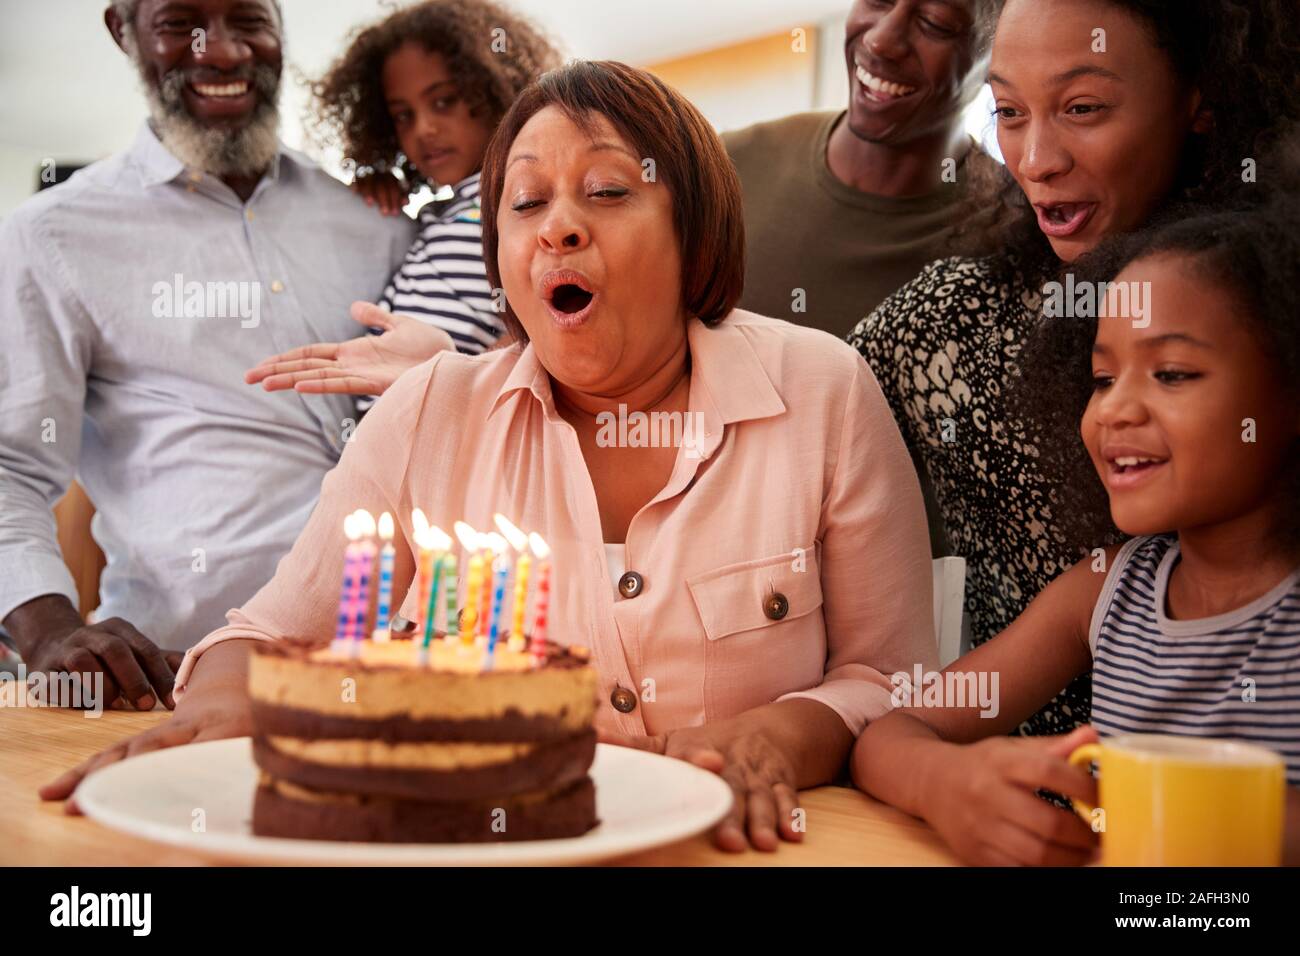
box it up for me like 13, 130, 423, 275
1088, 535, 1300, 786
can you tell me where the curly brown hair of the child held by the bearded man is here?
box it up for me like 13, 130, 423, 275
307, 0, 560, 187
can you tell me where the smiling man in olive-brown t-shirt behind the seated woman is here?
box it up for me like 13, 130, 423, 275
723, 0, 993, 338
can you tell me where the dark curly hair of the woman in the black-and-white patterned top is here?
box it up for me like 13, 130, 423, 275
953, 0, 1300, 278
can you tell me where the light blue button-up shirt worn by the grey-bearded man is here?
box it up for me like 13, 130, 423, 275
0, 124, 416, 649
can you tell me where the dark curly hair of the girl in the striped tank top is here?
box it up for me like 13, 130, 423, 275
1011, 189, 1300, 553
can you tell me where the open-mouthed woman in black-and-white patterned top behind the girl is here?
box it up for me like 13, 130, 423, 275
849, 0, 1300, 734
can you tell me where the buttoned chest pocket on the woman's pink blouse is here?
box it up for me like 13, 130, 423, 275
686, 548, 822, 641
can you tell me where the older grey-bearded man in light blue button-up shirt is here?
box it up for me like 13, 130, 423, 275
0, 0, 413, 708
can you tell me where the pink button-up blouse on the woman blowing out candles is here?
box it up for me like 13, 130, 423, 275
176, 310, 937, 735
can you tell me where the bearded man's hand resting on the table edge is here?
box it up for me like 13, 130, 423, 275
4, 594, 182, 710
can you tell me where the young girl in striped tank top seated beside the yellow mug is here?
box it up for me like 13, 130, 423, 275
853, 196, 1300, 865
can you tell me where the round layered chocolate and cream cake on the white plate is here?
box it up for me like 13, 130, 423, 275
248, 639, 597, 843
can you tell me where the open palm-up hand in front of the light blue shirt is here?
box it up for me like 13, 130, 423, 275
244, 302, 455, 395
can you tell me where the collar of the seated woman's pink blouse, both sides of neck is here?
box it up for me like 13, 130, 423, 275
488, 308, 785, 444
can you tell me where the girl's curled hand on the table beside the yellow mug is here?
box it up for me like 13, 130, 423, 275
926, 727, 1097, 866
